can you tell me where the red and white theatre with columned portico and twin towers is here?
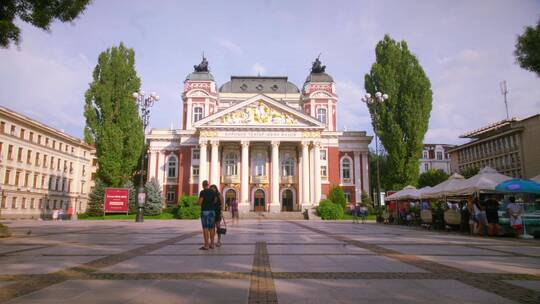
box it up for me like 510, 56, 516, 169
147, 58, 371, 212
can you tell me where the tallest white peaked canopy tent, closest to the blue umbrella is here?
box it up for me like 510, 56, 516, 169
446, 167, 512, 196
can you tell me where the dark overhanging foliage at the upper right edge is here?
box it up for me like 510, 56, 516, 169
514, 20, 540, 77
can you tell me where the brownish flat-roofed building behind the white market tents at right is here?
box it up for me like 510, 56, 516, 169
449, 114, 540, 178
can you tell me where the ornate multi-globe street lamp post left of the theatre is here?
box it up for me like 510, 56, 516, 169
133, 90, 159, 222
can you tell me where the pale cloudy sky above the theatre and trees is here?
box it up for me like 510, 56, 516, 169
0, 0, 540, 143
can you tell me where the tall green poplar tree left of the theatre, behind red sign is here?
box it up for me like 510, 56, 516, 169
84, 43, 144, 187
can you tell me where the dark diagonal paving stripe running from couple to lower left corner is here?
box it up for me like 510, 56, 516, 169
0, 232, 199, 303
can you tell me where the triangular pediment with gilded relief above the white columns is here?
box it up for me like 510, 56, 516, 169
194, 94, 325, 128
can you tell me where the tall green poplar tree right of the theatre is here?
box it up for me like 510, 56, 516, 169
364, 35, 432, 189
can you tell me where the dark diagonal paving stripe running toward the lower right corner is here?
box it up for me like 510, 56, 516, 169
290, 222, 540, 304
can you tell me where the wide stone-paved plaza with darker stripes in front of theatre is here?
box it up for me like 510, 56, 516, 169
0, 220, 540, 304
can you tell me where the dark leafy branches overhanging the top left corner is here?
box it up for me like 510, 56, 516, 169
0, 0, 90, 48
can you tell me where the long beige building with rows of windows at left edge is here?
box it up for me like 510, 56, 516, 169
0, 107, 95, 219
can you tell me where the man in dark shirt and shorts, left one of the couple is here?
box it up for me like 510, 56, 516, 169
197, 180, 216, 250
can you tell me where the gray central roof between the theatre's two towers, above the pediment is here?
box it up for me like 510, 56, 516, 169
219, 76, 300, 94
